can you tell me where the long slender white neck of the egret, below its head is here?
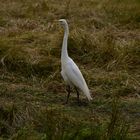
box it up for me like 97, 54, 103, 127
61, 25, 69, 61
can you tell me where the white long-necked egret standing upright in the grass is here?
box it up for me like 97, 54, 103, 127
59, 19, 92, 103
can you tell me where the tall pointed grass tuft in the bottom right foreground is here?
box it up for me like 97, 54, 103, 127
106, 98, 129, 140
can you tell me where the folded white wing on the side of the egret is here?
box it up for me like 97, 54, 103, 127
65, 59, 86, 89
